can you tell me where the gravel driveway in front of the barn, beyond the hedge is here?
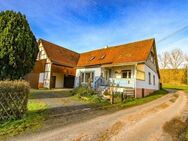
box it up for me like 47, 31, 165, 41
29, 89, 90, 116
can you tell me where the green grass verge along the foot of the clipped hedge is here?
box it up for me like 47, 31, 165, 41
0, 102, 47, 140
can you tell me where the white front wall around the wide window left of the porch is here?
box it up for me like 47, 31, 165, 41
74, 67, 101, 87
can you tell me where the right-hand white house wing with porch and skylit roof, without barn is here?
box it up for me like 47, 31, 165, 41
75, 39, 160, 97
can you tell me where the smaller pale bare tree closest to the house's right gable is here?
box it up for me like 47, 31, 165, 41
158, 51, 170, 69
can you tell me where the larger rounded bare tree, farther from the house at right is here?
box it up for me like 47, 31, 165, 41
169, 49, 185, 69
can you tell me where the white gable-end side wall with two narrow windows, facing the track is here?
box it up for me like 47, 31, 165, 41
136, 65, 159, 90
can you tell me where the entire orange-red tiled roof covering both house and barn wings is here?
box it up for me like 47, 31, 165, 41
39, 39, 155, 68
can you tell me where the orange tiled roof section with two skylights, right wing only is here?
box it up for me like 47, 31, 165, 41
77, 39, 154, 67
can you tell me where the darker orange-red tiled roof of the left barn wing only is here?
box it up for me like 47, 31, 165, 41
39, 39, 80, 67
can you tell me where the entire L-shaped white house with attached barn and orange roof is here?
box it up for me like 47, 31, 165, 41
25, 39, 160, 97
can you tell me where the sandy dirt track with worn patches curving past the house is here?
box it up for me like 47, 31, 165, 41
11, 92, 187, 141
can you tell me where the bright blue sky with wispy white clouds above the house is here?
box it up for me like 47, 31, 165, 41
0, 0, 188, 53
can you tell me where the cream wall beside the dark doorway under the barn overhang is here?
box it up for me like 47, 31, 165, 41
52, 73, 64, 88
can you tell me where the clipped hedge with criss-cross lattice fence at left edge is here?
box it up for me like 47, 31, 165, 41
0, 80, 30, 121
